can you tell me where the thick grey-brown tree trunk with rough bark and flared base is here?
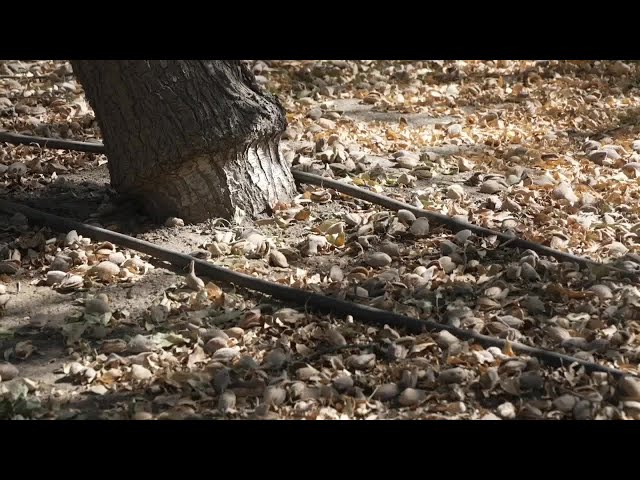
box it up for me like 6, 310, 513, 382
71, 60, 295, 222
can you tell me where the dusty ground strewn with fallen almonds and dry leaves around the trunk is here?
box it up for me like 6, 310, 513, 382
0, 61, 640, 419
